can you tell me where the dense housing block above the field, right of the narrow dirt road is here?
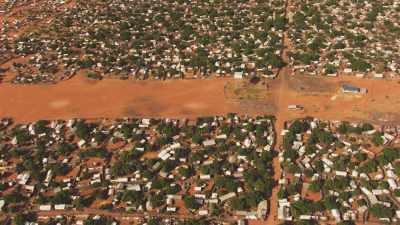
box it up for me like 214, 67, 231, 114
288, 0, 400, 78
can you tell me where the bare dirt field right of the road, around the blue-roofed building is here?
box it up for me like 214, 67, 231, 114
278, 72, 400, 124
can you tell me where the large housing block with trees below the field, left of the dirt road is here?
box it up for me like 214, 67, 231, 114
0, 114, 276, 225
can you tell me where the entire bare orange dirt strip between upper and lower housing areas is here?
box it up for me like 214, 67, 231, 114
0, 75, 400, 123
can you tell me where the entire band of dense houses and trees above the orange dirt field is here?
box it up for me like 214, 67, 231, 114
0, 0, 400, 83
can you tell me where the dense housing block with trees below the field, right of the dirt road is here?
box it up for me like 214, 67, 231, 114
278, 118, 400, 224
